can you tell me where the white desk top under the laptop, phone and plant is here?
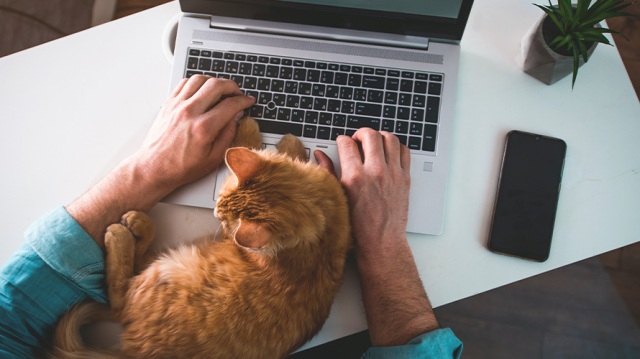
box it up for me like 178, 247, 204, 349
0, 0, 640, 352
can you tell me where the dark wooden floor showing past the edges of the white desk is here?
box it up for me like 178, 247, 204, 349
116, 0, 640, 359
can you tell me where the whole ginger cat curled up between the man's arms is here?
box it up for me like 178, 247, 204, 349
52, 118, 351, 358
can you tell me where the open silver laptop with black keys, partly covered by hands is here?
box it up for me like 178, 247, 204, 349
163, 0, 473, 235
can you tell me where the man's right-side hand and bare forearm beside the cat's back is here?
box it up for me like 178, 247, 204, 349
315, 128, 438, 346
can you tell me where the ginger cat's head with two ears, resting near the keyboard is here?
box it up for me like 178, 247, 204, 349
215, 147, 346, 256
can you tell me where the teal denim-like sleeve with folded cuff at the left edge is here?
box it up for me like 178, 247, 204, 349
0, 207, 106, 358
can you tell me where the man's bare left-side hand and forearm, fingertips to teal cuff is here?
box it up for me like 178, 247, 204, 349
67, 75, 255, 247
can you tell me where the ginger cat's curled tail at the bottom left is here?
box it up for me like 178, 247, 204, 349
49, 302, 119, 359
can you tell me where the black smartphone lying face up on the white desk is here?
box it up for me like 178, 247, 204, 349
488, 131, 567, 262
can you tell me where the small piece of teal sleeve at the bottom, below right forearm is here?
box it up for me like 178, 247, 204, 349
361, 328, 462, 359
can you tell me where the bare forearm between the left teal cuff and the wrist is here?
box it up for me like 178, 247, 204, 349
66, 153, 175, 248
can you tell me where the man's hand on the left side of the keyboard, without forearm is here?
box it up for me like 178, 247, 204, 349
134, 75, 255, 191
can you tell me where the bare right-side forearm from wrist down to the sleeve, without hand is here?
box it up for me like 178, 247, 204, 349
356, 239, 439, 346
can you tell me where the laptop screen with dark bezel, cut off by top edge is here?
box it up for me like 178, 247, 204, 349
180, 0, 473, 41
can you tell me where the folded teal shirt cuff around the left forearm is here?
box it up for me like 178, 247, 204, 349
25, 207, 107, 303
